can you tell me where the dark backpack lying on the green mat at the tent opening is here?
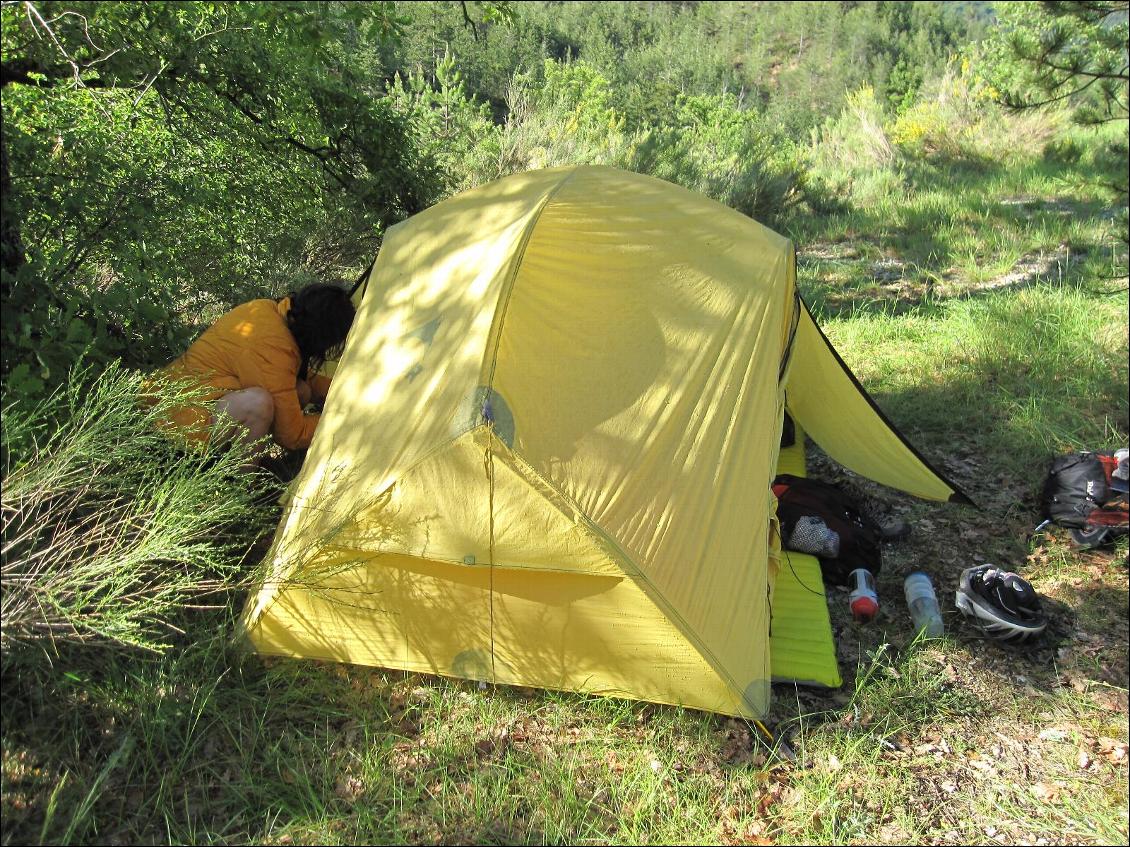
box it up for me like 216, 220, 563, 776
773, 473, 883, 585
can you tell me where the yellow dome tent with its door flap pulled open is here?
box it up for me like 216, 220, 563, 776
244, 167, 957, 717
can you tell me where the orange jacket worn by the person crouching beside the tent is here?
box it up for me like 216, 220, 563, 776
162, 297, 330, 449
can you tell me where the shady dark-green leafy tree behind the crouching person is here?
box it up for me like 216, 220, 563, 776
0, 2, 440, 390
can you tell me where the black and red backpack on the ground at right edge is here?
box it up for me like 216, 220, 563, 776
1040, 451, 1130, 547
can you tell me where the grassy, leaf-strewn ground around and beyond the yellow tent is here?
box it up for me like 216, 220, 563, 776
0, 112, 1130, 844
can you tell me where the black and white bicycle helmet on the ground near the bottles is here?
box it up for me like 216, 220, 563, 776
954, 565, 1048, 644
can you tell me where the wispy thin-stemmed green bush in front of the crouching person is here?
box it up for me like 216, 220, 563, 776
0, 366, 264, 656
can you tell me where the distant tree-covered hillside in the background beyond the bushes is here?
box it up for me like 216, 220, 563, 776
386, 0, 982, 138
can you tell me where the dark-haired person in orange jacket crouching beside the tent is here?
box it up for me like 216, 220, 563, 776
160, 282, 354, 451
